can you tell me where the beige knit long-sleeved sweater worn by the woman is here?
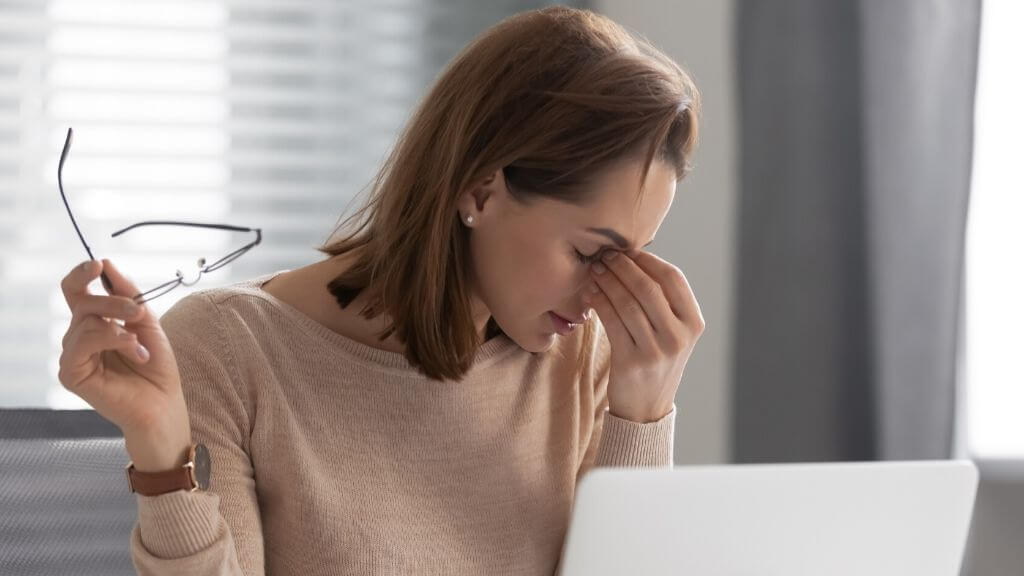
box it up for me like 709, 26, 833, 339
131, 271, 676, 576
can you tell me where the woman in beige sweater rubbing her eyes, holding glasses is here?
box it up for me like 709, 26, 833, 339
60, 7, 705, 575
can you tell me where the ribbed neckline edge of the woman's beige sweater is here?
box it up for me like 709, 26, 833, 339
241, 269, 519, 376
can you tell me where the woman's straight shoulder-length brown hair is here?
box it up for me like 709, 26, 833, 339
316, 6, 699, 379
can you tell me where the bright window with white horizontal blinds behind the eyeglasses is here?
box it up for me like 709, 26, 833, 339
0, 0, 577, 408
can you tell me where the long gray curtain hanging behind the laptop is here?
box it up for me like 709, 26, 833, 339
733, 0, 981, 462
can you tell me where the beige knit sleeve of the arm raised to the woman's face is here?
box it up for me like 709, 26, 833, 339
577, 313, 676, 475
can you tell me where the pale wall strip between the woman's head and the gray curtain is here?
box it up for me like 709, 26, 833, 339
591, 0, 739, 465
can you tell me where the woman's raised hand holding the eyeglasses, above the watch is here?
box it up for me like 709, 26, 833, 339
57, 259, 191, 471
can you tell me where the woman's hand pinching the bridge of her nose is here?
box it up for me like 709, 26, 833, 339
584, 250, 705, 422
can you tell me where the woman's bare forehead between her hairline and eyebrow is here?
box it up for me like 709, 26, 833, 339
565, 156, 676, 248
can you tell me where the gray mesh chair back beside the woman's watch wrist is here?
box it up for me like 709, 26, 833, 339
0, 409, 137, 576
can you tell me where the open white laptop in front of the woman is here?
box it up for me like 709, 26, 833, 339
559, 460, 978, 576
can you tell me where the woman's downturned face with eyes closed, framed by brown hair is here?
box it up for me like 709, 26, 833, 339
459, 160, 676, 353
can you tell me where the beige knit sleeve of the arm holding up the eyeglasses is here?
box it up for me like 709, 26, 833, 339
131, 292, 264, 576
